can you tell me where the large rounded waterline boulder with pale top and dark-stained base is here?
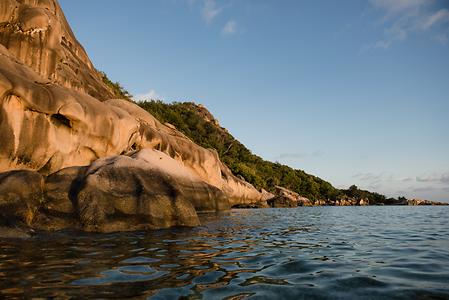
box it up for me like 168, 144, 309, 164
76, 149, 229, 232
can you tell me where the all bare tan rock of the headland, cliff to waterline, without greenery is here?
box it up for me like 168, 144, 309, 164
0, 0, 442, 237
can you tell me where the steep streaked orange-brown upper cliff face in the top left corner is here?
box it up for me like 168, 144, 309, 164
0, 0, 113, 100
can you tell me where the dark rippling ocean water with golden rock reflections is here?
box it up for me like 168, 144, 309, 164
0, 206, 449, 299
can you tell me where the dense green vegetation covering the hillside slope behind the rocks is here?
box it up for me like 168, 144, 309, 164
139, 100, 406, 204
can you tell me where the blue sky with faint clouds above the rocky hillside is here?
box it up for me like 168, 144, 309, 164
60, 0, 449, 202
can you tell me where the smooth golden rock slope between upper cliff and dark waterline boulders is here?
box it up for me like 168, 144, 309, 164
0, 54, 261, 203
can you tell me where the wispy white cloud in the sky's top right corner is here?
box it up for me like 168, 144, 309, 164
361, 0, 449, 52
